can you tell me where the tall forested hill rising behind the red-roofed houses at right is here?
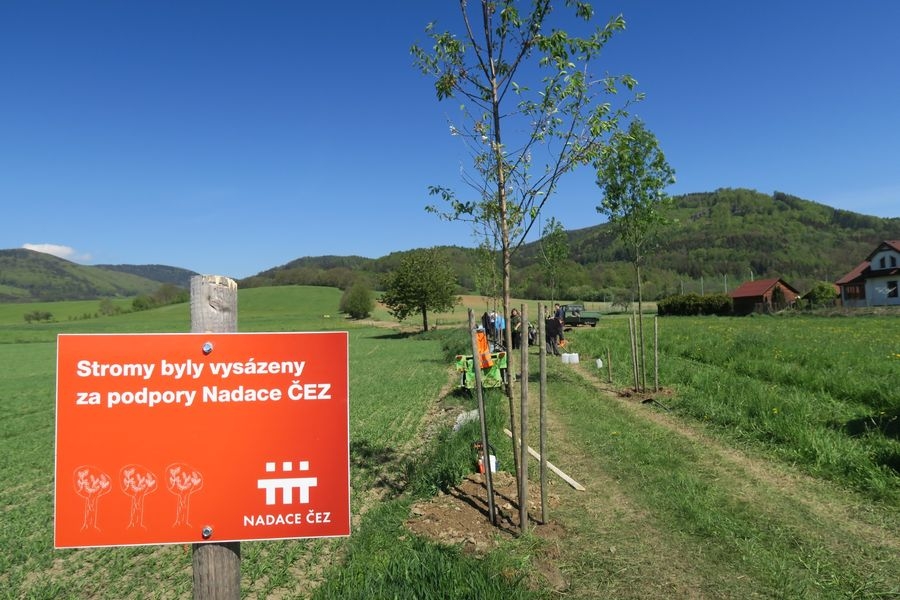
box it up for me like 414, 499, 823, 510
544, 189, 900, 296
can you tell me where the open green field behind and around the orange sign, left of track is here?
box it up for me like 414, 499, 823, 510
0, 288, 520, 598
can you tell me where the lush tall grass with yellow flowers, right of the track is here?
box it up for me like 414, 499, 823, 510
569, 316, 900, 504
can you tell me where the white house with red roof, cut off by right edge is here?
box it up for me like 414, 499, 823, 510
835, 240, 900, 307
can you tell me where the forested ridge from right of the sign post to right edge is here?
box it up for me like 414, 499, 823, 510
240, 189, 900, 300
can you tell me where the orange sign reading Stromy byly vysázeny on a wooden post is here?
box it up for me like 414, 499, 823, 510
55, 332, 350, 548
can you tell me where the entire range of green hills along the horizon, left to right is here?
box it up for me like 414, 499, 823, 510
0, 188, 900, 302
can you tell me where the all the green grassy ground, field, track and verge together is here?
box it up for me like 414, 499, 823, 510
0, 287, 900, 599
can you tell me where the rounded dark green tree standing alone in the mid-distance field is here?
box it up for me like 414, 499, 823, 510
381, 248, 459, 331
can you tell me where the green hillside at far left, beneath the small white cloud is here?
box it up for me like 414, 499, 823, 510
0, 249, 179, 302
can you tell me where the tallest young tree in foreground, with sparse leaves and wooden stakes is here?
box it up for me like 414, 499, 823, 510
412, 0, 636, 370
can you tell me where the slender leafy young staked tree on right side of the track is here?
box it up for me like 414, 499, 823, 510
596, 119, 675, 387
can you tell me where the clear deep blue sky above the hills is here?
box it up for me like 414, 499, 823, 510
0, 0, 900, 278
